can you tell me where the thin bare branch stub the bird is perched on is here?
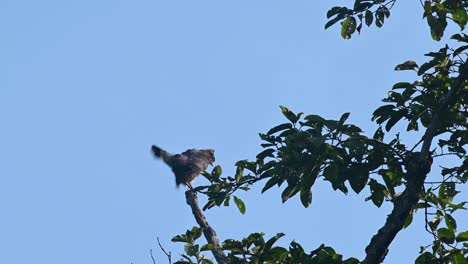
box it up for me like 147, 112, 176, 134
185, 190, 229, 264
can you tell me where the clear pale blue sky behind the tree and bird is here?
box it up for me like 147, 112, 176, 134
0, 0, 466, 264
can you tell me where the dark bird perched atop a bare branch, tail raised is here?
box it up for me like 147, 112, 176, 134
151, 145, 215, 190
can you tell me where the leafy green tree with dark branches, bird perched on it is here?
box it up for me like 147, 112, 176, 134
162, 0, 468, 264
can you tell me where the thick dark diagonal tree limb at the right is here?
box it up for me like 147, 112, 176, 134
362, 63, 468, 264
